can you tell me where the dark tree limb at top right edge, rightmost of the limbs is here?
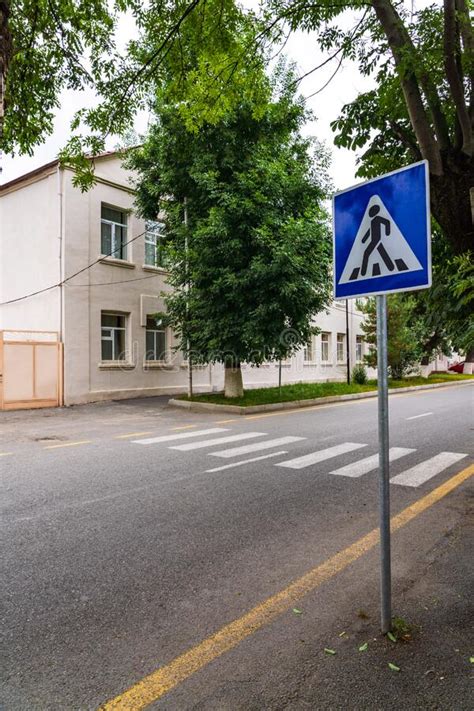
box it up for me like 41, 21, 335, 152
443, 0, 473, 156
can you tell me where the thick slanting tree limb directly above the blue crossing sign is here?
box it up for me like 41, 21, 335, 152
372, 0, 443, 175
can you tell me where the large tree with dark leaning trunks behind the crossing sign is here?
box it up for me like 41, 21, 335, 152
268, 0, 474, 254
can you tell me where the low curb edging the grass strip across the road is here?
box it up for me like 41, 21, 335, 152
168, 380, 473, 415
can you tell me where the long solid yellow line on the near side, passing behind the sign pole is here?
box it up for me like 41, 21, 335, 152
101, 465, 474, 711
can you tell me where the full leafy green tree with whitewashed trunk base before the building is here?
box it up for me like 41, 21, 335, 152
130, 70, 331, 396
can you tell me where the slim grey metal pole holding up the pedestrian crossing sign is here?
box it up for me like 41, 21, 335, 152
377, 294, 392, 634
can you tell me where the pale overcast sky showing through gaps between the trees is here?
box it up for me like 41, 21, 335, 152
0, 0, 427, 189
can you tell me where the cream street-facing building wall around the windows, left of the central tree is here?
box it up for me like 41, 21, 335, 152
64, 156, 209, 404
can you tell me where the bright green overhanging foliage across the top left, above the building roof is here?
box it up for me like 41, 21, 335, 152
0, 0, 272, 190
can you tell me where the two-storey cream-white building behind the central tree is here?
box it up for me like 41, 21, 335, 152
0, 153, 364, 407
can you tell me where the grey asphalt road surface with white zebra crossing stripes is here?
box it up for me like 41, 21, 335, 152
0, 385, 474, 710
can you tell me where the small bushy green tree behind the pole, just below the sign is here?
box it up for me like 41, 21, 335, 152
360, 294, 423, 379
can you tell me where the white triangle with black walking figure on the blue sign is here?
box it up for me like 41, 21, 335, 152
339, 195, 423, 284
